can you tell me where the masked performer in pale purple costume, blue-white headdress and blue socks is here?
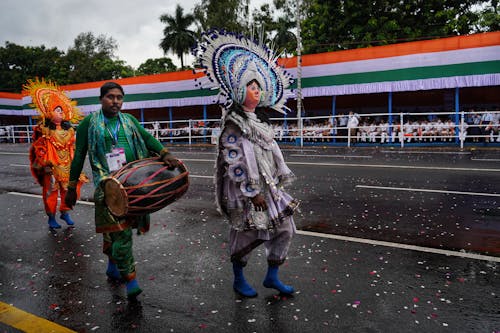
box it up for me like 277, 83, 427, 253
195, 31, 298, 297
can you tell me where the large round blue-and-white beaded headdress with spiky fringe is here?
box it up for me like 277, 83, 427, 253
193, 30, 292, 113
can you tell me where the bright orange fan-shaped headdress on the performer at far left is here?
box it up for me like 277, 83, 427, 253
23, 78, 83, 123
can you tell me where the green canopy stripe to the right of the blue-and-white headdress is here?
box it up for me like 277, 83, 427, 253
291, 60, 500, 89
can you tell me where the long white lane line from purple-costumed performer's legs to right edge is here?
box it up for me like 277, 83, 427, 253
297, 230, 500, 262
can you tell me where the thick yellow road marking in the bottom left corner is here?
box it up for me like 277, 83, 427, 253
0, 302, 76, 333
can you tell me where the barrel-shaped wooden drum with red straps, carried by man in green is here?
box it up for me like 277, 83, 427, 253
102, 157, 189, 217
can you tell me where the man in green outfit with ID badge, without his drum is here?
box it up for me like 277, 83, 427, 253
65, 82, 179, 299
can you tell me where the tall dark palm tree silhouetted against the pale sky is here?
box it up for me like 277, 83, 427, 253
160, 5, 196, 69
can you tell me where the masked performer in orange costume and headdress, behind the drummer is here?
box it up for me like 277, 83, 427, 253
23, 79, 88, 229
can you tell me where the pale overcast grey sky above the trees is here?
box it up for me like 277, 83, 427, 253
0, 0, 266, 68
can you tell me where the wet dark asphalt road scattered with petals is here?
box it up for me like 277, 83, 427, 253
0, 144, 500, 332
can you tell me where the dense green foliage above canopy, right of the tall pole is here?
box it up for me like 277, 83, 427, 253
302, 0, 484, 53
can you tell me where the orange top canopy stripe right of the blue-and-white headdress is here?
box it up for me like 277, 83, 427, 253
279, 31, 500, 68
